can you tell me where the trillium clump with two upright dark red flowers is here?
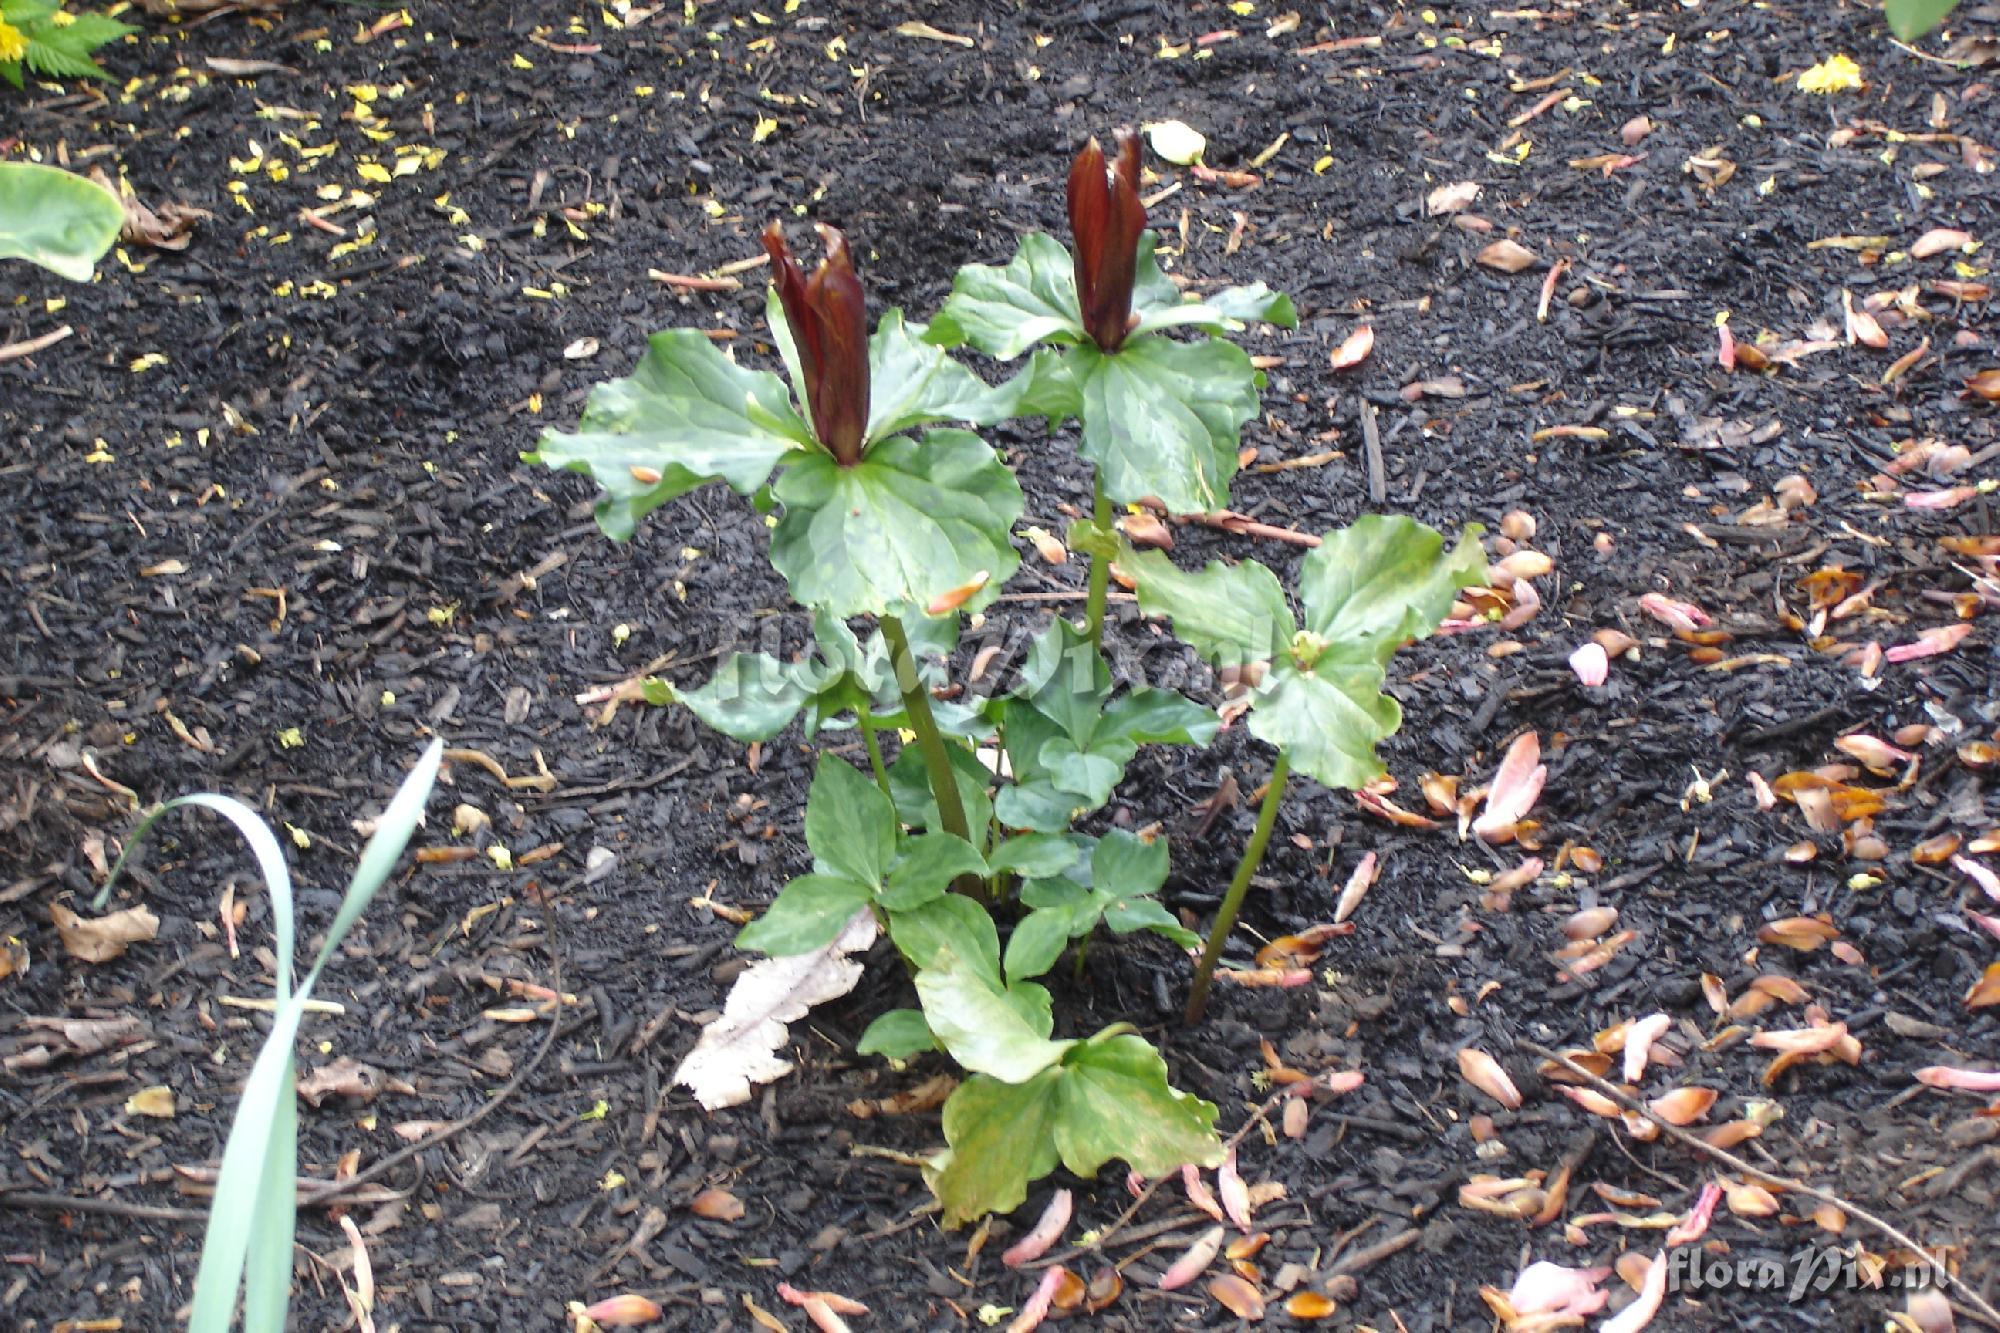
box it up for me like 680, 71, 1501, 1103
528, 136, 1484, 1225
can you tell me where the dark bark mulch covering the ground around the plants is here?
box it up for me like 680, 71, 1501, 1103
0, 0, 2000, 1331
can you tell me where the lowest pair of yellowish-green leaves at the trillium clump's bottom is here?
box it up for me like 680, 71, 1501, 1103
928, 1035, 1222, 1227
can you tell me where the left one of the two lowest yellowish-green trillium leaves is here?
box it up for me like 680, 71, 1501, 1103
928, 1069, 1062, 1227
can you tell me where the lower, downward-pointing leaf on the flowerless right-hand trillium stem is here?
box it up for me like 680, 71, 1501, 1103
1250, 658, 1402, 791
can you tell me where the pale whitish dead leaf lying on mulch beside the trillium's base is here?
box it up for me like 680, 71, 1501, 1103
674, 909, 876, 1111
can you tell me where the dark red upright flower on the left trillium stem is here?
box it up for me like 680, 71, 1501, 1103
764, 222, 868, 466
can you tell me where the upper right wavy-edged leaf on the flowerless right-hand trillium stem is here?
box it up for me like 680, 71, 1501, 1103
1298, 514, 1486, 664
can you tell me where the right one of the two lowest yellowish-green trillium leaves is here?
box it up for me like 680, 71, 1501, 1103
1048, 1035, 1222, 1177
